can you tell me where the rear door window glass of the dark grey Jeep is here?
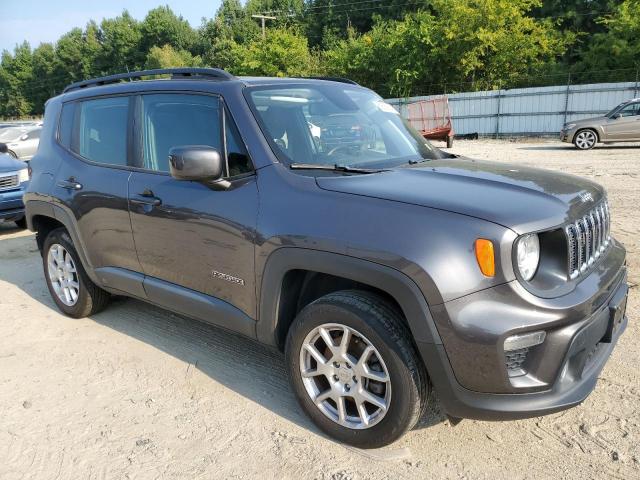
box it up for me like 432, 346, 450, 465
71, 97, 129, 165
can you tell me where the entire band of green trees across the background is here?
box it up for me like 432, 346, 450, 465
0, 0, 640, 117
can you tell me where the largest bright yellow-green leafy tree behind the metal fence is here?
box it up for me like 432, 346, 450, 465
326, 0, 572, 96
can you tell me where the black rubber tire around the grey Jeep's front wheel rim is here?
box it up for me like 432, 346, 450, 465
285, 290, 428, 448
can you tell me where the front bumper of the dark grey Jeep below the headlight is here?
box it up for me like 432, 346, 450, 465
418, 240, 628, 420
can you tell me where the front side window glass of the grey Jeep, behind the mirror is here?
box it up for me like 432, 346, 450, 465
142, 94, 222, 172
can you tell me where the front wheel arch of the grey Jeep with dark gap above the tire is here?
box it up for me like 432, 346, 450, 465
256, 247, 442, 348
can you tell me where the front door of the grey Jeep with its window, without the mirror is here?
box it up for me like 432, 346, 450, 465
129, 93, 258, 318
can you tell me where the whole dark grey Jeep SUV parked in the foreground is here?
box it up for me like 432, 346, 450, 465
25, 69, 627, 447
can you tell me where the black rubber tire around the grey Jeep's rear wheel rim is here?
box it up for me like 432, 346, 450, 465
42, 228, 109, 318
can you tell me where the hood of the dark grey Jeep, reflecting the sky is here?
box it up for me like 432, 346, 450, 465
316, 158, 604, 234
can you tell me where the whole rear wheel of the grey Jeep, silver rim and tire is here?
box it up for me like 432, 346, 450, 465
42, 228, 109, 318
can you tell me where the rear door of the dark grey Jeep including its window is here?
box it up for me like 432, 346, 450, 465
54, 96, 140, 271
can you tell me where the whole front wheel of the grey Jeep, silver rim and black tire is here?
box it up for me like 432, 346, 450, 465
285, 290, 428, 448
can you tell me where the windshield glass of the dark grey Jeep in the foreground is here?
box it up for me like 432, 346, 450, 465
248, 84, 445, 167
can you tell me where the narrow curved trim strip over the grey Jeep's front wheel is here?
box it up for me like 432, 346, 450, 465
256, 247, 442, 346
